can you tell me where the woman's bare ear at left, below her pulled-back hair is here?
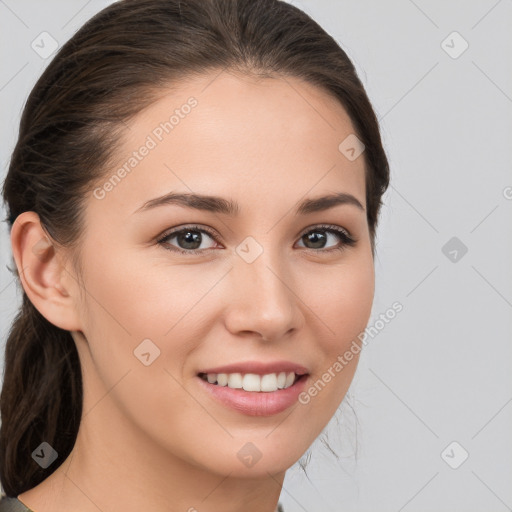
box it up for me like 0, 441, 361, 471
11, 211, 82, 331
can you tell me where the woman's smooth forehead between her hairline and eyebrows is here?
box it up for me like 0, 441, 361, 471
90, 71, 365, 218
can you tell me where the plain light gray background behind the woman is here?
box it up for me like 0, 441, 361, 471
0, 0, 512, 512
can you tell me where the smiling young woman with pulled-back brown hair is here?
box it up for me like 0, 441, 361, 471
0, 0, 389, 512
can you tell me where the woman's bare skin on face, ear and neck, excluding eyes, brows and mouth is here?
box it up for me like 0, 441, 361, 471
11, 71, 374, 512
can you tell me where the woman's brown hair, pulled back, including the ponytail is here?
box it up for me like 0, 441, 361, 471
0, 0, 389, 496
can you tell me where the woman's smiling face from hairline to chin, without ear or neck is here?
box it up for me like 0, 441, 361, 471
69, 71, 374, 477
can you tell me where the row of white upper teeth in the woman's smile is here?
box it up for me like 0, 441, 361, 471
199, 372, 296, 393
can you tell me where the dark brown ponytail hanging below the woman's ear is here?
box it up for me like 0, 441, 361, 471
0, 293, 82, 497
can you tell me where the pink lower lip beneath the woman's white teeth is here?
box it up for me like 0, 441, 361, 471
197, 375, 309, 416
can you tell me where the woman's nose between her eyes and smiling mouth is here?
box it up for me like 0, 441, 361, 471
225, 246, 304, 341
